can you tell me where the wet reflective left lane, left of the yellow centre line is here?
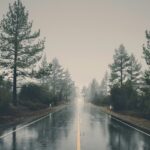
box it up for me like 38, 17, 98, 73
0, 108, 75, 150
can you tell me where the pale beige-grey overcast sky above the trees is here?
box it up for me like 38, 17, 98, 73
0, 0, 150, 87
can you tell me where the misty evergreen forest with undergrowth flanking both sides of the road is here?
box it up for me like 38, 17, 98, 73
0, 0, 150, 119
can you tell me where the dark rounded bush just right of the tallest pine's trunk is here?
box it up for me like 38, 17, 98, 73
19, 83, 51, 107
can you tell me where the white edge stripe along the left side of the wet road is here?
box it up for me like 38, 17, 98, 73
0, 114, 49, 139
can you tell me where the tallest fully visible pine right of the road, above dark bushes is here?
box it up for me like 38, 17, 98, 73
109, 45, 129, 87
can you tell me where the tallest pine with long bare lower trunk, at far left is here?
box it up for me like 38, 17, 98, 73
0, 0, 44, 105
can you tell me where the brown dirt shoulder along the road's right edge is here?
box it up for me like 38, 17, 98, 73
91, 104, 150, 133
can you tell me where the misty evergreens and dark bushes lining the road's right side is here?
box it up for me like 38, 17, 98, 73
82, 31, 150, 116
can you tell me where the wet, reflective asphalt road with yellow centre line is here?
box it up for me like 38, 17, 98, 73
0, 98, 150, 150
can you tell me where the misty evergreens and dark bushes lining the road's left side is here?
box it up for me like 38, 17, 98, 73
0, 0, 76, 111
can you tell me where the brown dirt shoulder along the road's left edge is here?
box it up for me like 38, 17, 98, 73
0, 104, 67, 127
